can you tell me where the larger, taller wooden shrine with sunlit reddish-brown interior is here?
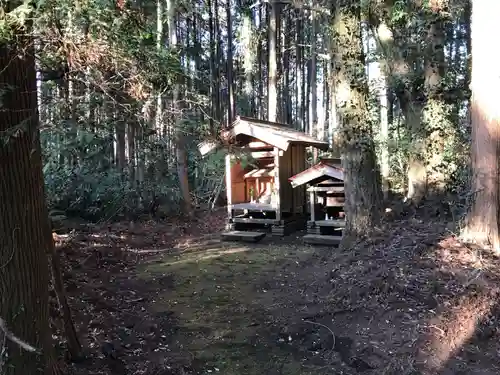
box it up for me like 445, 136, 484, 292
199, 117, 329, 241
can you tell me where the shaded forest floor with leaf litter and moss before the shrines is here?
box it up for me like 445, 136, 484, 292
58, 209, 500, 375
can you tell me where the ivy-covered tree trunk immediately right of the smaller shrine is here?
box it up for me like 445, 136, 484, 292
334, 0, 382, 243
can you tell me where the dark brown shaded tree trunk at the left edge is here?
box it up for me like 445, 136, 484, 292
0, 20, 56, 375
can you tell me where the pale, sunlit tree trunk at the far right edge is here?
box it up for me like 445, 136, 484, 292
462, 0, 500, 252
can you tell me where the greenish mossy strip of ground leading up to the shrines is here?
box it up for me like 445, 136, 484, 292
137, 244, 326, 375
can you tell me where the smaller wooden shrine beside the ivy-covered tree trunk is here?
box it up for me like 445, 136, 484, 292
289, 159, 345, 245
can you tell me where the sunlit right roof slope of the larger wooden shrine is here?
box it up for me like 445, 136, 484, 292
230, 117, 329, 151
